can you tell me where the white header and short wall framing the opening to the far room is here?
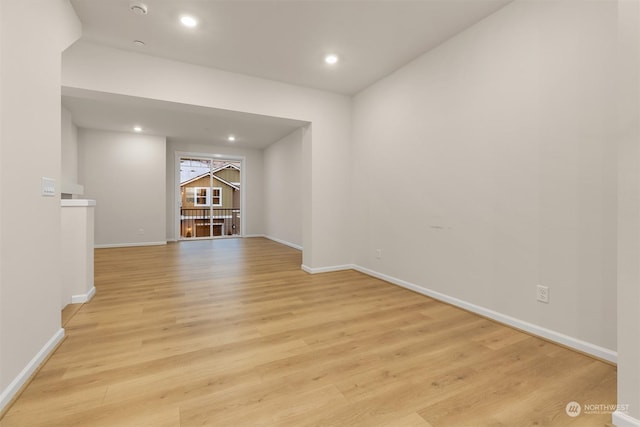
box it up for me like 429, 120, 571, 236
62, 42, 351, 268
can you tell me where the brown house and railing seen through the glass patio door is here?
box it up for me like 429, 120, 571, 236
179, 158, 241, 239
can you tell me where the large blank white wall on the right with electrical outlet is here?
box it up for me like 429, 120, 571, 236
351, 1, 616, 358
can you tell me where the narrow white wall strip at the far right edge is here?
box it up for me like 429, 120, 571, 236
613, 1, 640, 427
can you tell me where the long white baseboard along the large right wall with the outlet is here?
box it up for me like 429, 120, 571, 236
352, 265, 618, 363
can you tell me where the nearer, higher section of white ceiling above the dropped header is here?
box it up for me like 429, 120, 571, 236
72, 0, 510, 95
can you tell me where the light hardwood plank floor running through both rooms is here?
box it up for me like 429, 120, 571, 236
0, 238, 616, 427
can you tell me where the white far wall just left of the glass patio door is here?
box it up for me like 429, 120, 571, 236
78, 128, 167, 247
